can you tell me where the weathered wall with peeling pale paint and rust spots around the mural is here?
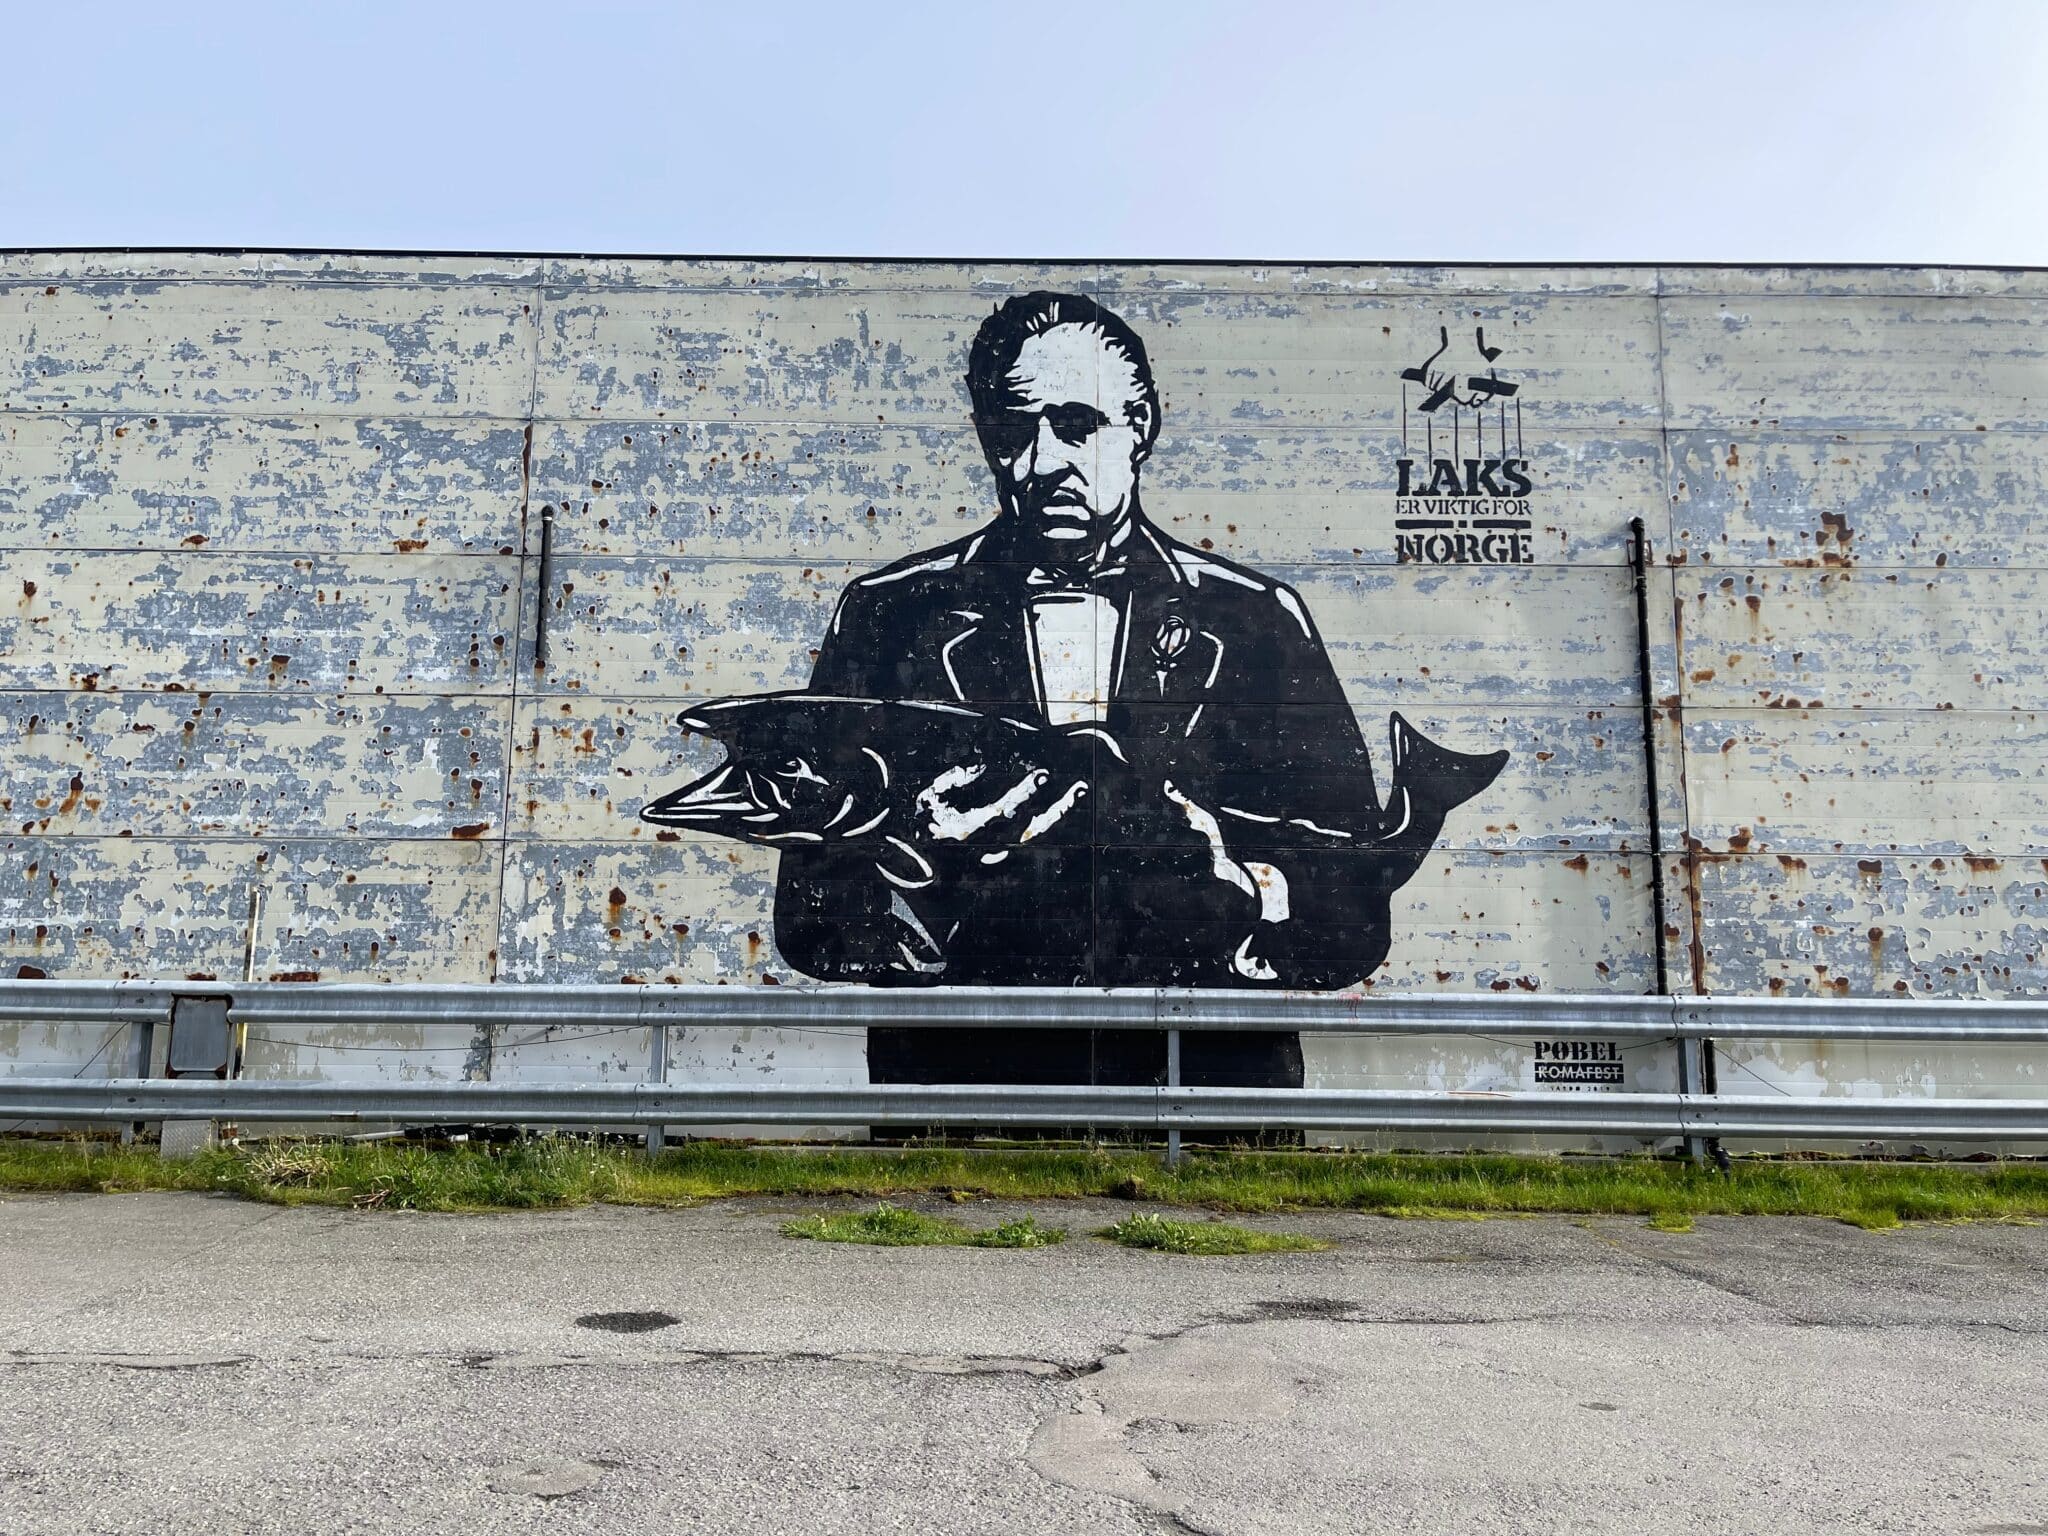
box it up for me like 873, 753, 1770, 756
0, 254, 2048, 1122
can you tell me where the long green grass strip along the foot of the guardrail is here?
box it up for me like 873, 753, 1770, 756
0, 1137, 2048, 1227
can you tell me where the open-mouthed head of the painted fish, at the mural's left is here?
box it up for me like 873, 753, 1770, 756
641, 694, 887, 846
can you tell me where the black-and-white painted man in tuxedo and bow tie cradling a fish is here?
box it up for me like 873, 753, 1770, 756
745, 293, 1505, 1085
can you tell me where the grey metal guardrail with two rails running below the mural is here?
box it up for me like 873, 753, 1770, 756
0, 981, 2048, 1151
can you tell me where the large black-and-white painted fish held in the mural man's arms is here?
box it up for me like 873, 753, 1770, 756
641, 692, 1507, 854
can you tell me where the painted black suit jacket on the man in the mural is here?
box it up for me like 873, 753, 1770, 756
776, 516, 1413, 1048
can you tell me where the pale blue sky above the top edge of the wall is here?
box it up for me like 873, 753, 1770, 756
0, 0, 2048, 264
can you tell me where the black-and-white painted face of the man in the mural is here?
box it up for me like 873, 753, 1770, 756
981, 326, 1153, 543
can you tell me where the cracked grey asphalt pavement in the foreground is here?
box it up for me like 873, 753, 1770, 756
0, 1194, 2048, 1536
